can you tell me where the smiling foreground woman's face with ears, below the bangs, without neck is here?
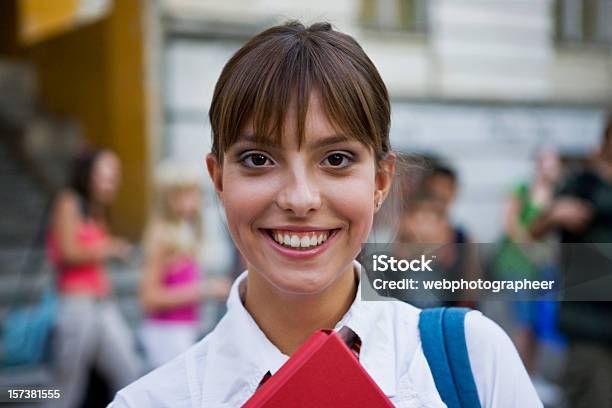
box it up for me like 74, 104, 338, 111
207, 93, 395, 294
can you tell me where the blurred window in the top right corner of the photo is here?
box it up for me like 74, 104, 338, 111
555, 0, 612, 45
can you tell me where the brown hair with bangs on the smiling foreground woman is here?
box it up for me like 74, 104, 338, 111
209, 21, 391, 161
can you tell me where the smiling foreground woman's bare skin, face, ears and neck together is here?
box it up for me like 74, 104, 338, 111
208, 91, 395, 355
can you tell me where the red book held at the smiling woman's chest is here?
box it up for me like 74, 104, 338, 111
243, 330, 393, 408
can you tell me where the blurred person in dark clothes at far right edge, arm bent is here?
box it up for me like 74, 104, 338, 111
530, 116, 612, 408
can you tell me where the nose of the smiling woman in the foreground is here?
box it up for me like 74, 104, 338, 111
277, 165, 321, 217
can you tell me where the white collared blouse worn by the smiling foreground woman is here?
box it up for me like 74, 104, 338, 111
109, 264, 542, 408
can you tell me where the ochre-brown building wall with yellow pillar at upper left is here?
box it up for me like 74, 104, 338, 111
24, 1, 150, 238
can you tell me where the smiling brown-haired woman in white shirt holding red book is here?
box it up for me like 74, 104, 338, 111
114, 22, 541, 407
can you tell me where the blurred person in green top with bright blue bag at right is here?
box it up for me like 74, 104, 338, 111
494, 148, 561, 404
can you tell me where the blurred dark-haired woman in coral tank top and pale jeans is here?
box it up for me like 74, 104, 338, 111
47, 150, 141, 408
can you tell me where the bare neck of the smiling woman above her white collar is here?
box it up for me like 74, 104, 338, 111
243, 264, 357, 355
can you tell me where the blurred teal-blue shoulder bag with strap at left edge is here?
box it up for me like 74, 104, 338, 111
0, 201, 59, 367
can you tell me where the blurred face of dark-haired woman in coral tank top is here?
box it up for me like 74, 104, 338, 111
91, 151, 121, 204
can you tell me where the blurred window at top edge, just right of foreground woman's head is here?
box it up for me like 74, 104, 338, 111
360, 0, 428, 33
